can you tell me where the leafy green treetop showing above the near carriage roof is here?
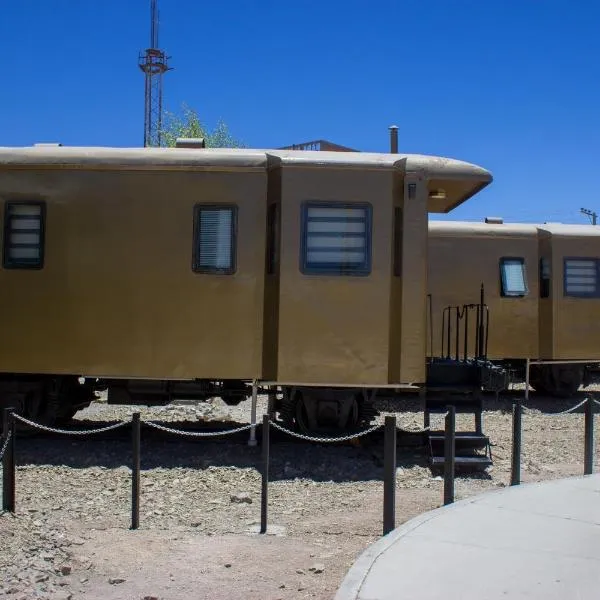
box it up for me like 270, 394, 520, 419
161, 104, 247, 148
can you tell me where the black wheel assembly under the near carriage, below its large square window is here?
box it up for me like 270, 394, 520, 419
279, 389, 375, 436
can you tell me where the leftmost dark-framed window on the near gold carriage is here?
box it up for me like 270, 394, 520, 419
3, 202, 46, 269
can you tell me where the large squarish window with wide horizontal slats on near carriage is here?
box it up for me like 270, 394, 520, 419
301, 202, 372, 275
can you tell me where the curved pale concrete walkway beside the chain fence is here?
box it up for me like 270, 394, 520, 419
335, 474, 600, 600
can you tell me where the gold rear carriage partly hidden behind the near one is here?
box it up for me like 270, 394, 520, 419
428, 219, 600, 397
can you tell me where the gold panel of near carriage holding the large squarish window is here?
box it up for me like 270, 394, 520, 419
278, 165, 393, 385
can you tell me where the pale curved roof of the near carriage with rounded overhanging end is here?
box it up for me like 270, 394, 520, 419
0, 144, 493, 213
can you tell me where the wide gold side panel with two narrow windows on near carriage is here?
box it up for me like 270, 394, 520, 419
0, 168, 267, 379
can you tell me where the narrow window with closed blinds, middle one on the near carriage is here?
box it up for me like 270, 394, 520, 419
193, 204, 237, 275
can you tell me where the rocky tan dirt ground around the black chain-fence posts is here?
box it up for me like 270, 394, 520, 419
0, 387, 600, 600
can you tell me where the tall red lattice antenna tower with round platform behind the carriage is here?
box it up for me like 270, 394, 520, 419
138, 0, 171, 146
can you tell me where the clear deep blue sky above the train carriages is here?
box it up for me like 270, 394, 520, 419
0, 0, 600, 222
